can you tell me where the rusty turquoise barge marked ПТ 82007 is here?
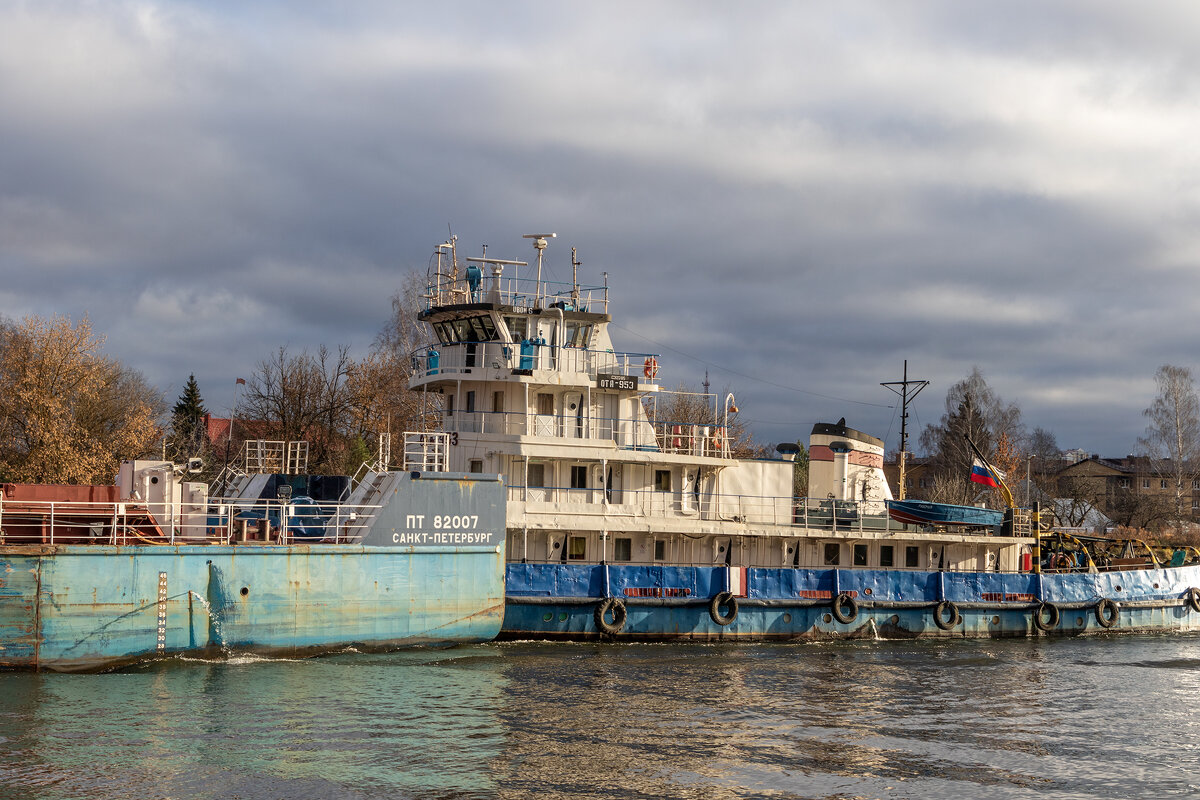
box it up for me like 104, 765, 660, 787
0, 453, 505, 672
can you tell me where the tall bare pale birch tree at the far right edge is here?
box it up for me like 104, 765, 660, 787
1138, 365, 1200, 528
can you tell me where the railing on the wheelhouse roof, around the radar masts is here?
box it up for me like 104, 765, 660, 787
422, 272, 608, 314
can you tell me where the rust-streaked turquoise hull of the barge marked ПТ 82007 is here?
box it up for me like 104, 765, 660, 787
0, 545, 504, 670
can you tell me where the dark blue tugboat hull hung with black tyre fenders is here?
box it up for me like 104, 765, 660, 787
500, 564, 1200, 642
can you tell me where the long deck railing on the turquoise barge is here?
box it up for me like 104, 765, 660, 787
0, 498, 378, 546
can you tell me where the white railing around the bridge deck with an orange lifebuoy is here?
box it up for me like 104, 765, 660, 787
409, 339, 658, 387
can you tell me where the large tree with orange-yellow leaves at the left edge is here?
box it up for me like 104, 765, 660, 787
0, 315, 164, 483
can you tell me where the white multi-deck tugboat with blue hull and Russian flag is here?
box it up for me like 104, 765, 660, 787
409, 234, 1200, 642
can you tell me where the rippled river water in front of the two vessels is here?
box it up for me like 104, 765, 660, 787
0, 636, 1200, 800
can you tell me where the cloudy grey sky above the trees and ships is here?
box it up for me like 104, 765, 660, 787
0, 0, 1200, 457
